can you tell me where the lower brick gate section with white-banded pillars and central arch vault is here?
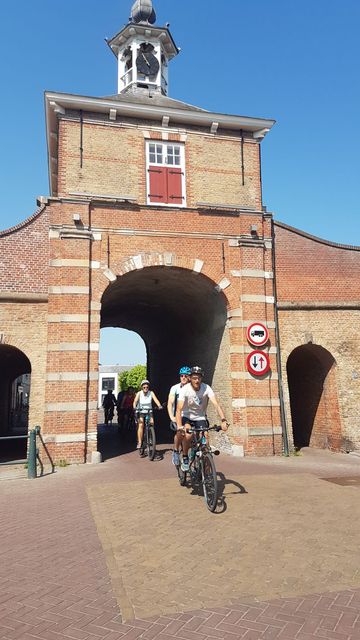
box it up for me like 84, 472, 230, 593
42, 194, 281, 460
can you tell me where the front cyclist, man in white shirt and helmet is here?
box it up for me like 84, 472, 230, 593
176, 367, 228, 471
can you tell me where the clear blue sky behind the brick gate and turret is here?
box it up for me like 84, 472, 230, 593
0, 0, 360, 364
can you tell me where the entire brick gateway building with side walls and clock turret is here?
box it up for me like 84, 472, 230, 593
0, 0, 360, 462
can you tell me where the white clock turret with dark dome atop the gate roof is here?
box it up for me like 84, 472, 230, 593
107, 0, 179, 96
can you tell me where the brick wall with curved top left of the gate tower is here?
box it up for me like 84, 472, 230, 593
0, 207, 49, 442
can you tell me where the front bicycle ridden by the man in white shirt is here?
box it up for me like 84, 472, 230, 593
177, 425, 221, 513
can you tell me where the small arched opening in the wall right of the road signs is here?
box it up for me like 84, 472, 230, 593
287, 344, 342, 451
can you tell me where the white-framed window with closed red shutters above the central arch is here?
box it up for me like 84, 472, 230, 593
147, 142, 186, 207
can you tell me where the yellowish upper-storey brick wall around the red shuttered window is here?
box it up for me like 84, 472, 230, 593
58, 119, 261, 208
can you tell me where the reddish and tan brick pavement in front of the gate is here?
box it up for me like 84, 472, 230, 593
0, 428, 360, 640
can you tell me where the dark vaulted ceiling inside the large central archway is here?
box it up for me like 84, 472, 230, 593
101, 266, 231, 440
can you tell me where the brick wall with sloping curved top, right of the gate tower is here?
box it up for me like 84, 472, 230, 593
275, 224, 360, 450
